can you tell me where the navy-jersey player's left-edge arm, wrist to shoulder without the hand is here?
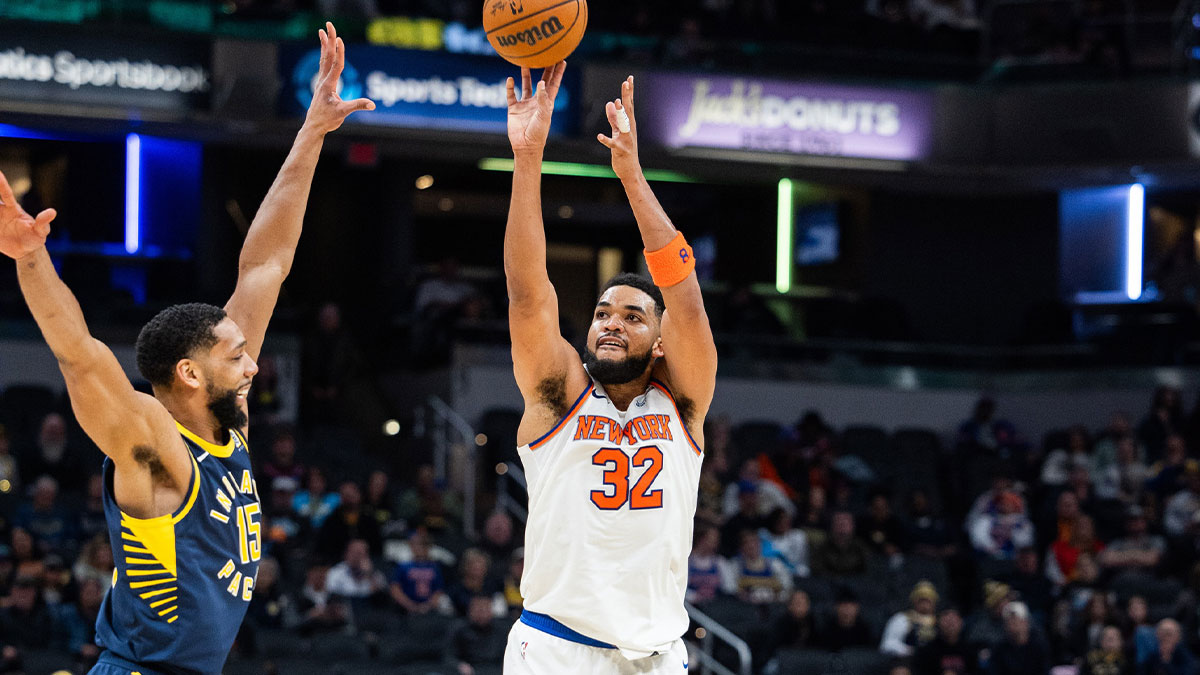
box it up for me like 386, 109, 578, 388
17, 247, 192, 478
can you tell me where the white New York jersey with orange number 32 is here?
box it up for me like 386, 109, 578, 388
518, 381, 703, 659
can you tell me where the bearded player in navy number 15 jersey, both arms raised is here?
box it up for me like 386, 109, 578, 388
0, 24, 373, 675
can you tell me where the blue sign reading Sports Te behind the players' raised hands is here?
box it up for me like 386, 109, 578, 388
280, 44, 576, 133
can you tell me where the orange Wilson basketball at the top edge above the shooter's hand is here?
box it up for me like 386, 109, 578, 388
484, 0, 588, 68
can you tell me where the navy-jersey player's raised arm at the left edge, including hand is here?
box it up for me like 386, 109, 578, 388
0, 174, 192, 502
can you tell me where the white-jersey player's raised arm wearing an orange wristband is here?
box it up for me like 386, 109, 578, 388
598, 77, 716, 424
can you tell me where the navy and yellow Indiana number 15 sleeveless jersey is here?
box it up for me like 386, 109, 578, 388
96, 425, 262, 675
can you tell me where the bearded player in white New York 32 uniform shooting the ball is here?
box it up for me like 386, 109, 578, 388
504, 64, 716, 675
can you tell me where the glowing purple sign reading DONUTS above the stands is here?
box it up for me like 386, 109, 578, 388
637, 73, 934, 160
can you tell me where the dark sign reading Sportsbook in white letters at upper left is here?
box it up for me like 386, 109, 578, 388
0, 30, 211, 109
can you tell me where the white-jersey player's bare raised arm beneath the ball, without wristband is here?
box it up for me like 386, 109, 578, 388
504, 61, 586, 410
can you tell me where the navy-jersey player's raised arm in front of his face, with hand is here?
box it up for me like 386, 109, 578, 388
224, 23, 374, 359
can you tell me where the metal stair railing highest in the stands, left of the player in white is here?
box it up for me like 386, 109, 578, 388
413, 396, 475, 537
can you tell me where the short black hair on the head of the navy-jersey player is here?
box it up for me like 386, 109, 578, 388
134, 303, 227, 387
